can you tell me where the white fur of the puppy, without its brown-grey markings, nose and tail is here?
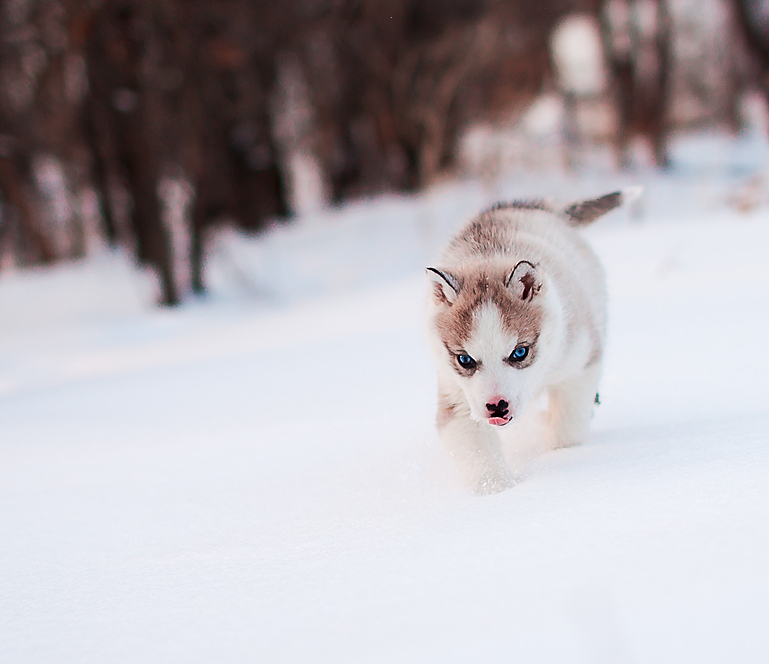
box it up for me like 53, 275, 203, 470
428, 197, 629, 493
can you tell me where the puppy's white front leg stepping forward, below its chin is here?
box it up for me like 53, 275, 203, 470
438, 394, 513, 494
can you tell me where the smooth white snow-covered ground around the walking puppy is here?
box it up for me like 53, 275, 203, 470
0, 131, 769, 664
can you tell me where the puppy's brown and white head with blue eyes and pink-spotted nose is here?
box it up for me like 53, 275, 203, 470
428, 261, 547, 426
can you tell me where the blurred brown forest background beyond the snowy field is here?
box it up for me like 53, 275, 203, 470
0, 0, 769, 304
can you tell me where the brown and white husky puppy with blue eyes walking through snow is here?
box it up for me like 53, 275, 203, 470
427, 190, 639, 493
